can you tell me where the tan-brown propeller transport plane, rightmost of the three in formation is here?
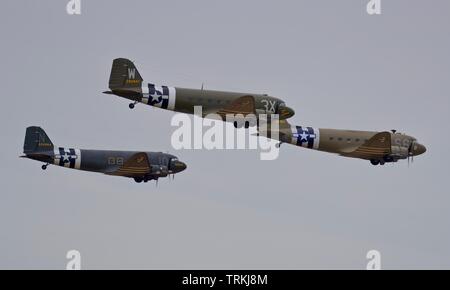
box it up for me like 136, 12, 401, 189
259, 120, 426, 165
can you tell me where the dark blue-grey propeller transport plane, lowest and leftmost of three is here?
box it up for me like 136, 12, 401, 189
20, 126, 186, 182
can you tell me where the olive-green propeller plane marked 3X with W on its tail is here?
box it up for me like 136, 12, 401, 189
104, 58, 294, 128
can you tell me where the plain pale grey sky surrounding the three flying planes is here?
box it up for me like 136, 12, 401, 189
0, 0, 450, 269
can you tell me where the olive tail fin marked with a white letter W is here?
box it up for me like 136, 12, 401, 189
109, 58, 142, 91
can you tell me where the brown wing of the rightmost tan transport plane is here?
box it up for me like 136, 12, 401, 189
341, 132, 391, 159
